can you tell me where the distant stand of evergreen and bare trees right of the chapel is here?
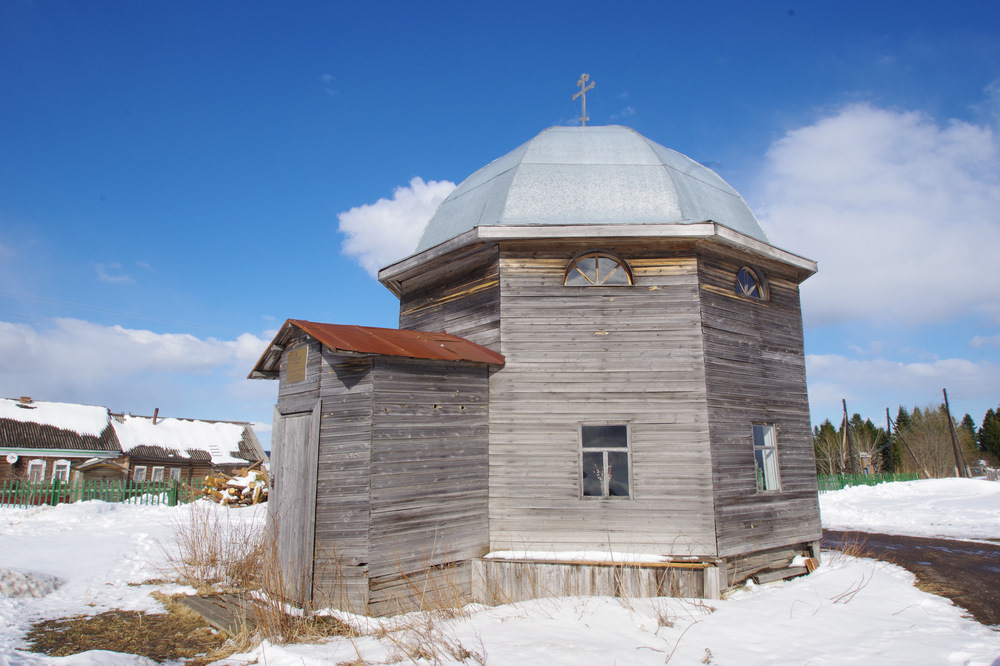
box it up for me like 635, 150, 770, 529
813, 403, 1000, 478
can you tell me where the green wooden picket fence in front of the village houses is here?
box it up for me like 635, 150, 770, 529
0, 479, 200, 507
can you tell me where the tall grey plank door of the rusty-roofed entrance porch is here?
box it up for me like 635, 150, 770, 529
268, 401, 322, 606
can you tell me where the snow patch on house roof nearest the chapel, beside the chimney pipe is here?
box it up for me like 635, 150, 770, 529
112, 415, 247, 465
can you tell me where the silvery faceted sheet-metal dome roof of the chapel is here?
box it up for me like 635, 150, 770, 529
416, 125, 769, 252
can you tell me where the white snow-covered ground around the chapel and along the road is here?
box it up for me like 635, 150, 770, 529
0, 479, 1000, 666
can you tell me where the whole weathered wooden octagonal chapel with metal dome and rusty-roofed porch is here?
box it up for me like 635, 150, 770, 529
251, 126, 821, 613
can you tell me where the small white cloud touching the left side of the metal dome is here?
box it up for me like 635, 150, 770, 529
337, 177, 455, 277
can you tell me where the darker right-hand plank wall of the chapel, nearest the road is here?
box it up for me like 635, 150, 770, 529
699, 248, 821, 556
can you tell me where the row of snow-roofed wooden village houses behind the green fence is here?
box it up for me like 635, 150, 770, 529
0, 397, 266, 482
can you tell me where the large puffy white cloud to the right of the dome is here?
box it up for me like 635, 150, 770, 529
757, 104, 1000, 325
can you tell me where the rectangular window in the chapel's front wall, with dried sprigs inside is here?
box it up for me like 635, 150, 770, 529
580, 425, 631, 497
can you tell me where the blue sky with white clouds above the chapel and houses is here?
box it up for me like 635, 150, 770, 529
0, 0, 1000, 446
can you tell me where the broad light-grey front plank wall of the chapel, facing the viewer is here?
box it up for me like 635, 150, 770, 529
490, 241, 715, 556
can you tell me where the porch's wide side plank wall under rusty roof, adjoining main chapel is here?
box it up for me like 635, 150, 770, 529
369, 357, 489, 607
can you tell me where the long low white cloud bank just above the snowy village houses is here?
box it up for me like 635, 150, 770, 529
0, 319, 275, 419
